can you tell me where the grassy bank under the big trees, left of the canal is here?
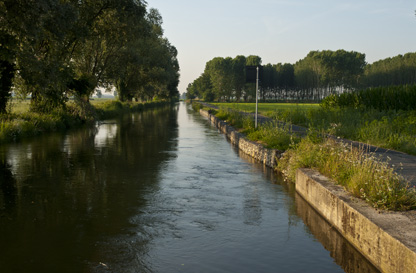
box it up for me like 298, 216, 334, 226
0, 100, 172, 143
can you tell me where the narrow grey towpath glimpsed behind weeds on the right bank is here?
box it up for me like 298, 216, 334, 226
202, 103, 416, 187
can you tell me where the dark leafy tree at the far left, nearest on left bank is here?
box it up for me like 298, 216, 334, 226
0, 0, 77, 110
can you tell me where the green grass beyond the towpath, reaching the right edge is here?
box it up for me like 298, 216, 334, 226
211, 103, 416, 155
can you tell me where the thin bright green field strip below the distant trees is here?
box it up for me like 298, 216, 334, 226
210, 103, 319, 115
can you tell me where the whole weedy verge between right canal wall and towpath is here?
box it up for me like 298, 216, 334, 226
197, 102, 416, 210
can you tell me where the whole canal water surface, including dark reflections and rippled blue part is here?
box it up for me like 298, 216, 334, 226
0, 104, 376, 273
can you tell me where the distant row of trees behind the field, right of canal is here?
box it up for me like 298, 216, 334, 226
187, 50, 416, 101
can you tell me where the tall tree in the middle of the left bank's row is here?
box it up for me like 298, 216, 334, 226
73, 0, 150, 102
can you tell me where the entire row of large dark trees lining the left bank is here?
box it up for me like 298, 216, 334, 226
0, 0, 179, 112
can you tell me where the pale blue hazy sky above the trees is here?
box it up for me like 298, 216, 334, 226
147, 0, 416, 94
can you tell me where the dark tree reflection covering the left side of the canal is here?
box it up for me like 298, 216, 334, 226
0, 107, 178, 273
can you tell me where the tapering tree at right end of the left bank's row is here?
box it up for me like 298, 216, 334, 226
110, 9, 179, 101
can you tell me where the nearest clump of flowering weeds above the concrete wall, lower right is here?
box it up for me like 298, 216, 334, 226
277, 138, 416, 211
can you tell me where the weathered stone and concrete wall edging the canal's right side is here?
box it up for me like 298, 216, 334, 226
200, 109, 416, 273
